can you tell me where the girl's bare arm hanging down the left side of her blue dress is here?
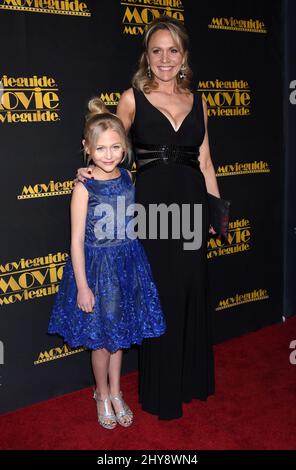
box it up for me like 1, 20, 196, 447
71, 182, 95, 312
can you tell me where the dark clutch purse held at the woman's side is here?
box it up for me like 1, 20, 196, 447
208, 193, 230, 237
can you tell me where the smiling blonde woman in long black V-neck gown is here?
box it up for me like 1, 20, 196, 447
81, 17, 219, 419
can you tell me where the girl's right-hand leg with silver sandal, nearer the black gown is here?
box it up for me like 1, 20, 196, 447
108, 349, 133, 427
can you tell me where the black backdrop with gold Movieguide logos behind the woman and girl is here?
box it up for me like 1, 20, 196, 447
0, 0, 284, 412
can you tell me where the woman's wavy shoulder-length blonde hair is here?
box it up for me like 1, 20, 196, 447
132, 16, 193, 93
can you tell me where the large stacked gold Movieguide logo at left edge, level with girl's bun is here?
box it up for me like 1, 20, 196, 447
0, 75, 60, 124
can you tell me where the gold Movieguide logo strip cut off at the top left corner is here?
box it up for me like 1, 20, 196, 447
0, 0, 91, 16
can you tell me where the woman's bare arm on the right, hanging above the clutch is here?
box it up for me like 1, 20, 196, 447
198, 100, 220, 197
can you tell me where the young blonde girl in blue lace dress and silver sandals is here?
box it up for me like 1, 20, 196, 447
48, 98, 165, 429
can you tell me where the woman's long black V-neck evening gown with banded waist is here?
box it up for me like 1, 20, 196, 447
131, 88, 214, 419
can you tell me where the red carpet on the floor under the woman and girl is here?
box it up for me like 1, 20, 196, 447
0, 317, 296, 450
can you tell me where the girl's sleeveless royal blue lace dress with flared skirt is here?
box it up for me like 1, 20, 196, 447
48, 168, 165, 352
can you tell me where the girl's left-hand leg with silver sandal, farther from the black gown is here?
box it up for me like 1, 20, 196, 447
91, 349, 116, 429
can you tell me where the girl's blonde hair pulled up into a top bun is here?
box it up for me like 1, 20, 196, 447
84, 96, 131, 165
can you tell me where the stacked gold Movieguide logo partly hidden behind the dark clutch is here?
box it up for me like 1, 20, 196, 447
207, 219, 252, 259
